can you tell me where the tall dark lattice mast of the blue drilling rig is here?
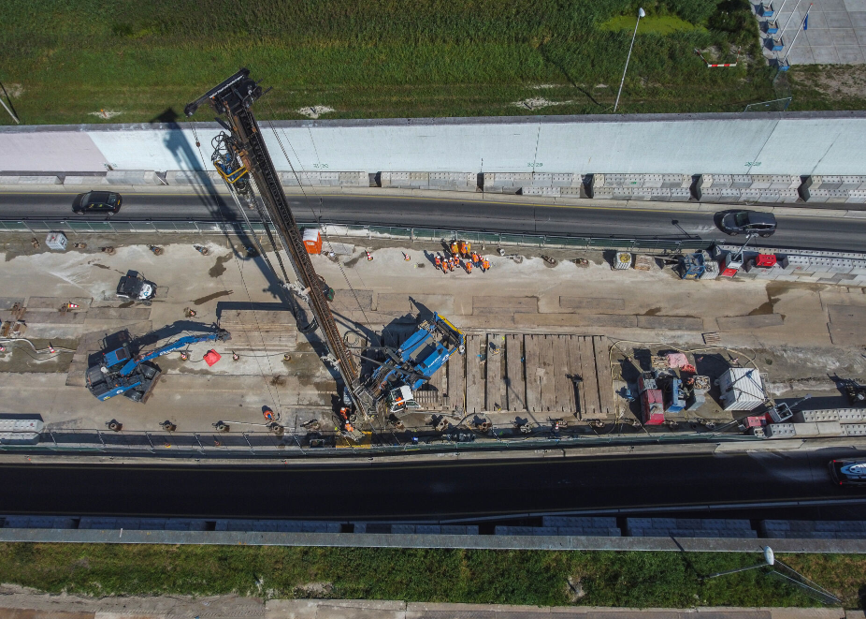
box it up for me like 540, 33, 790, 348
184, 69, 367, 414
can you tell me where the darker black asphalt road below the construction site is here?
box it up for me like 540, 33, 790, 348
0, 449, 866, 520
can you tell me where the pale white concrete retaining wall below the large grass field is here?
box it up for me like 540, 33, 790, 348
0, 112, 866, 176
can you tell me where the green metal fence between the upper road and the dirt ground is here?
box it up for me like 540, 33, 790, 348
0, 219, 713, 251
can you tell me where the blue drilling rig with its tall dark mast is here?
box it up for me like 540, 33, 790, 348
184, 69, 464, 427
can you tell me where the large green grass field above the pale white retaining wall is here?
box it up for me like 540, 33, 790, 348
0, 0, 788, 124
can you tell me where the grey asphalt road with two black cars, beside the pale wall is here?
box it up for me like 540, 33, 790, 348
0, 193, 866, 251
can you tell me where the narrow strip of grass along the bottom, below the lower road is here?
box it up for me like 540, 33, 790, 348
0, 544, 866, 608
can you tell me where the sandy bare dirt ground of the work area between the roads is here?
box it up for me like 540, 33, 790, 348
0, 234, 866, 440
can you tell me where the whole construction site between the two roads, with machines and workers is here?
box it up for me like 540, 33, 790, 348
0, 69, 866, 458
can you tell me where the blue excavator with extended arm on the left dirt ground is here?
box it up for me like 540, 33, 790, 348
87, 327, 231, 404
